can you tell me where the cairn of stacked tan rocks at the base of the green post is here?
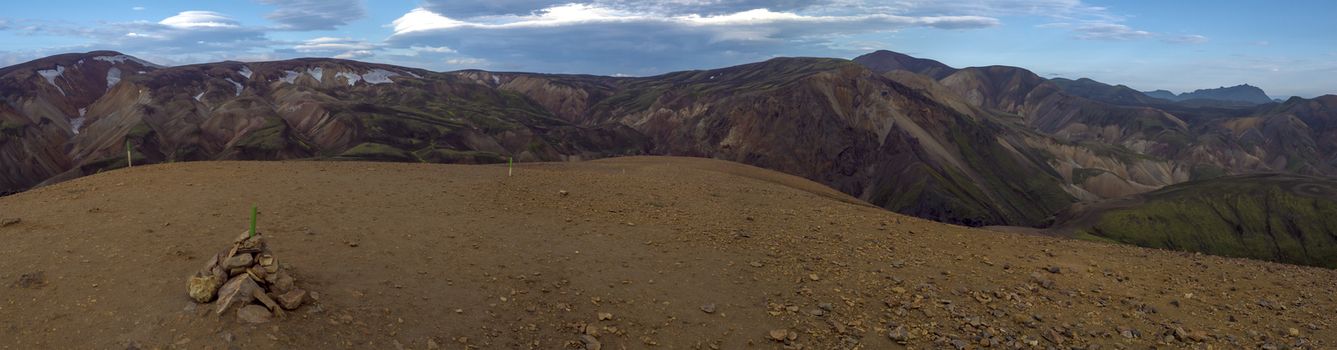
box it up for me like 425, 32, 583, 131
186, 232, 308, 323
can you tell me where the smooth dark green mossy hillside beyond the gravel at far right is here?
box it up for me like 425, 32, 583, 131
1079, 176, 1337, 267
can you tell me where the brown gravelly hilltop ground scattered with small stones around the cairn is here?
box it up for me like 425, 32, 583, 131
0, 158, 1337, 349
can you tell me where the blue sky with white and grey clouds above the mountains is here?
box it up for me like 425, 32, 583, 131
0, 0, 1337, 98
